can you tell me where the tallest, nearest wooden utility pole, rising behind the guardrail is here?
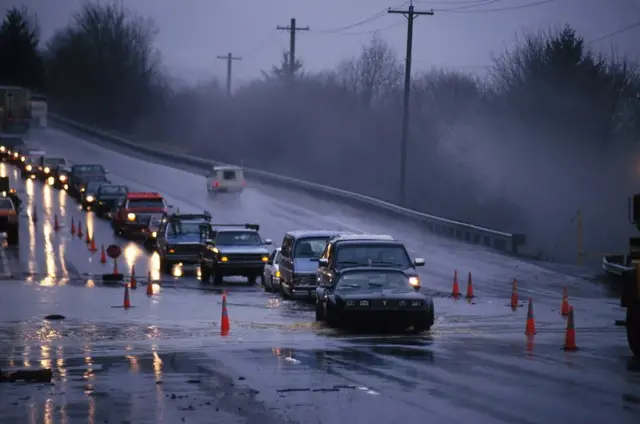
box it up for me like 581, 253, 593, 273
389, 1, 434, 206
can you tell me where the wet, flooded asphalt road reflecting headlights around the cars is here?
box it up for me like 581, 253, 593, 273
0, 130, 640, 423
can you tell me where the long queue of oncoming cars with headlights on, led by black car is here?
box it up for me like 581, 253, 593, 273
0, 147, 435, 332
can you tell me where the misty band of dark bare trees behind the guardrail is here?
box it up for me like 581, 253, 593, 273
0, 3, 640, 259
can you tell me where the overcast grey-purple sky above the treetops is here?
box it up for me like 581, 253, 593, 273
5, 0, 640, 84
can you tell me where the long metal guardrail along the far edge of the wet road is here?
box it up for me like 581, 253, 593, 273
49, 113, 526, 254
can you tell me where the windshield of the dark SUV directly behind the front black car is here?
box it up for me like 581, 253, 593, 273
335, 243, 411, 268
